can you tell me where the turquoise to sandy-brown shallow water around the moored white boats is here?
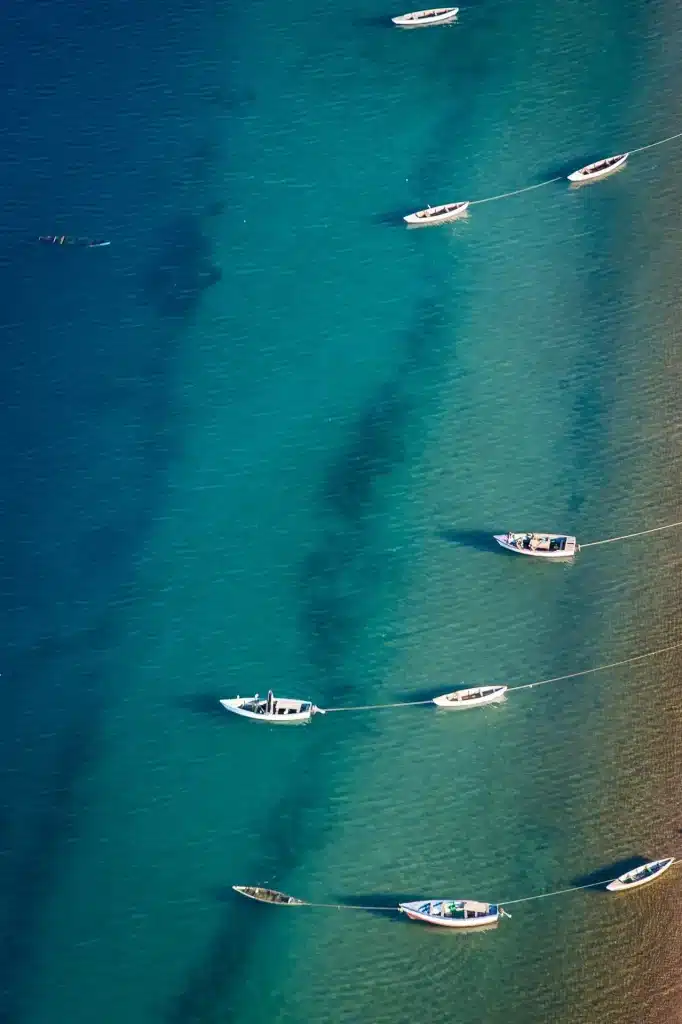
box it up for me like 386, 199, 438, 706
5, 3, 682, 1024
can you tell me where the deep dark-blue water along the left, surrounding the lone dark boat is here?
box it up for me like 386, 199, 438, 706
0, 2, 230, 1021
